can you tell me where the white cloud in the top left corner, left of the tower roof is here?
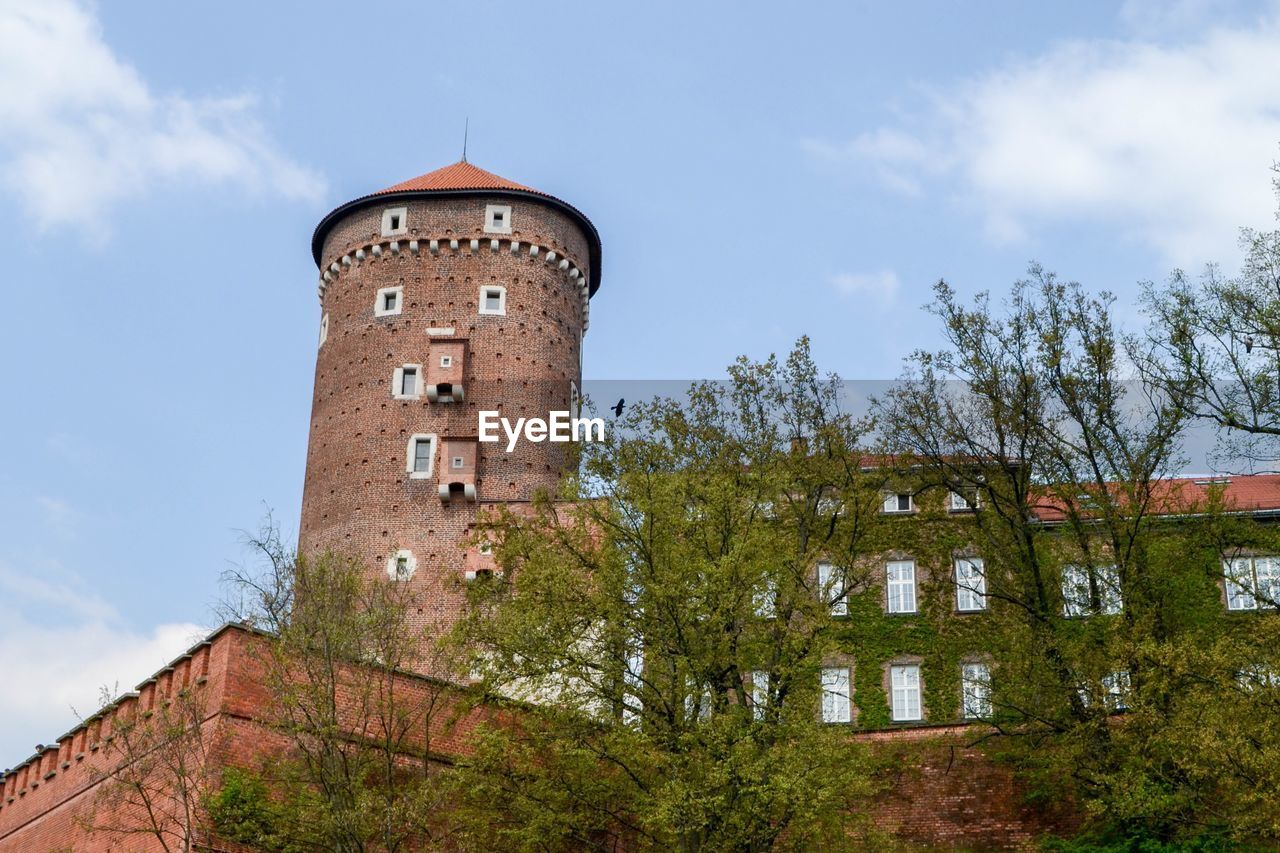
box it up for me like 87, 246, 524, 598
0, 0, 324, 236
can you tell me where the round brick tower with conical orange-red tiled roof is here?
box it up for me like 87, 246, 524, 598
298, 160, 600, 669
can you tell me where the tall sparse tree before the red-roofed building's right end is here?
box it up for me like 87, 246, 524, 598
879, 268, 1280, 840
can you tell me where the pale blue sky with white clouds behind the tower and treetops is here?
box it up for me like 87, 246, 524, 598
0, 0, 1280, 767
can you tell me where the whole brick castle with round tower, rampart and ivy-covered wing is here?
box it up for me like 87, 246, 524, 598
0, 160, 1280, 853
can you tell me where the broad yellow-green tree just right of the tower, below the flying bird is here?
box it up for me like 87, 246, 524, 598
453, 341, 884, 850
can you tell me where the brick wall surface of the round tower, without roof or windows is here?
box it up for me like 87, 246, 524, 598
300, 197, 589, 671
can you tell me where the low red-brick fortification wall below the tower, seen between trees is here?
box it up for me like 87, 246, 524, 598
0, 625, 1076, 853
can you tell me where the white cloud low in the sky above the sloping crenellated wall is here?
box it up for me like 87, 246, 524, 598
0, 564, 204, 767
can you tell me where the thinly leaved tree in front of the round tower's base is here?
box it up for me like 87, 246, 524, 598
214, 524, 449, 852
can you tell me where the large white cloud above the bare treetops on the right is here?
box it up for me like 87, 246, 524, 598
805, 17, 1280, 266
